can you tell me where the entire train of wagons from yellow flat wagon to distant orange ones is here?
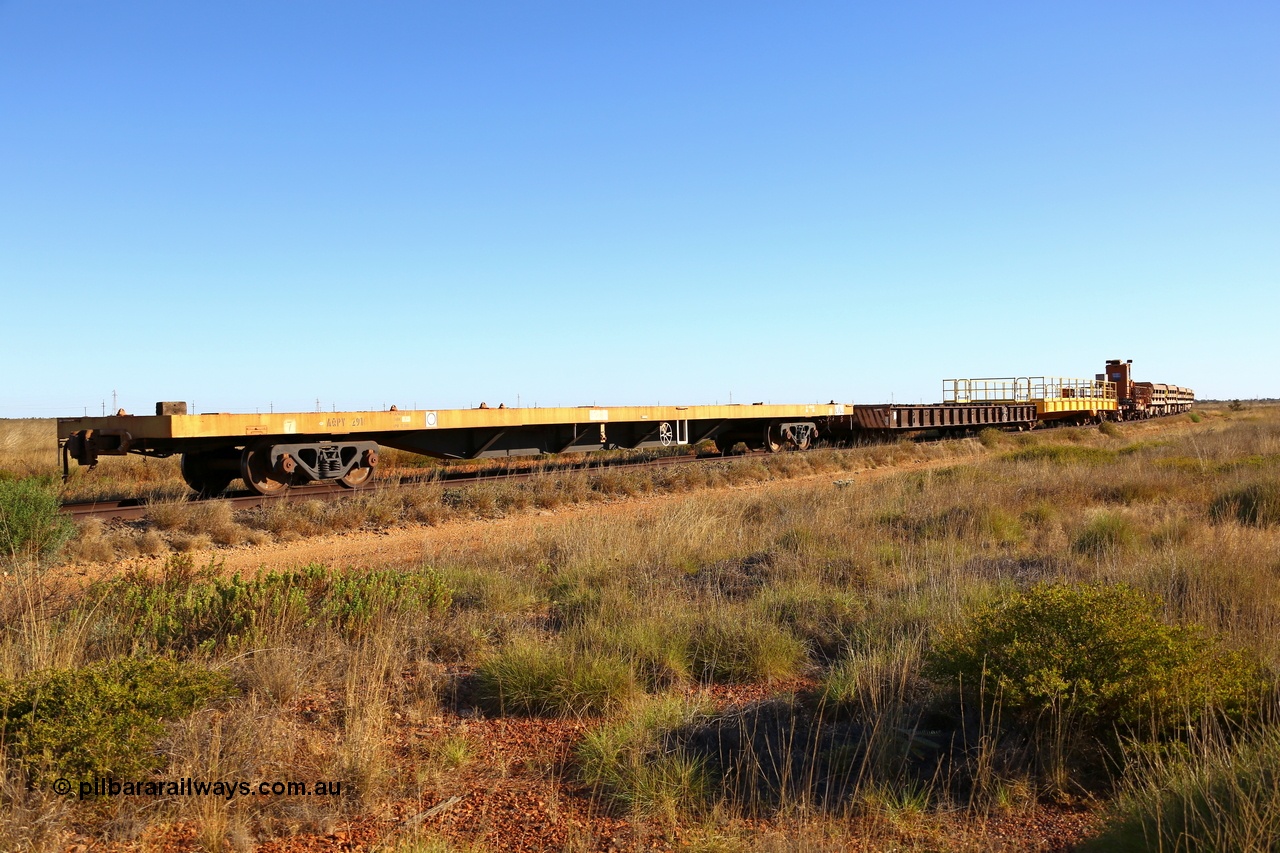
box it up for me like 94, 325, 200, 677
49, 360, 1194, 496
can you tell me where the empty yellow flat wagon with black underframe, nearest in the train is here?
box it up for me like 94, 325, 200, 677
58, 402, 847, 494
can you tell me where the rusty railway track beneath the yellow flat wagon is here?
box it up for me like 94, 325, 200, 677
61, 451, 771, 521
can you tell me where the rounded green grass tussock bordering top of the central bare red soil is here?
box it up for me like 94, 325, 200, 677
475, 640, 639, 716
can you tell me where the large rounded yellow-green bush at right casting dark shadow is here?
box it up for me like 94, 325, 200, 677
928, 584, 1261, 730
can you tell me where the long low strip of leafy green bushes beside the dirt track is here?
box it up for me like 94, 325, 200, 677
76, 555, 451, 651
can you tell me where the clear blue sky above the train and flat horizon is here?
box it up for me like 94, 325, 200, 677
0, 0, 1280, 416
